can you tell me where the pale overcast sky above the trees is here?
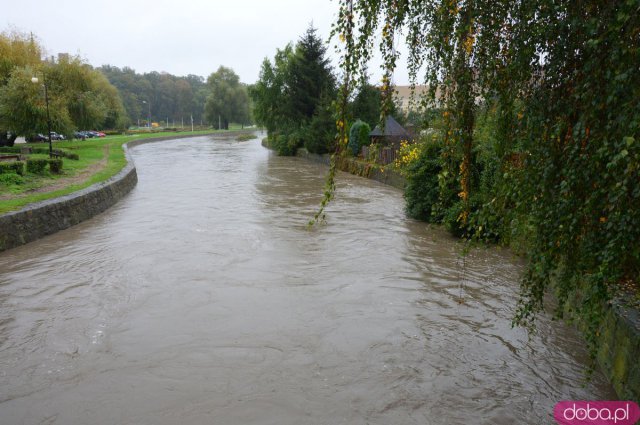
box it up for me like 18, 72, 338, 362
0, 0, 406, 84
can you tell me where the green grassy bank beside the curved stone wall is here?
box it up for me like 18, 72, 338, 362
0, 125, 250, 214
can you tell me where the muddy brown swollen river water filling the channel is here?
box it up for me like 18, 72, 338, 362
0, 136, 615, 425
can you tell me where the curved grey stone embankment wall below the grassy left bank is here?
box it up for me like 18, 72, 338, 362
0, 134, 212, 252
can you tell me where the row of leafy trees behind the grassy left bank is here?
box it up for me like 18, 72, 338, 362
0, 32, 251, 145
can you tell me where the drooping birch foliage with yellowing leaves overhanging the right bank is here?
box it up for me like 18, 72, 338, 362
320, 0, 640, 360
